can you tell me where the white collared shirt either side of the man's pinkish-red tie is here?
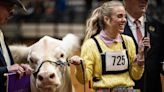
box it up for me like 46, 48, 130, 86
127, 13, 145, 42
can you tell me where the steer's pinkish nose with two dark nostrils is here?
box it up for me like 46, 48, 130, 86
37, 72, 55, 81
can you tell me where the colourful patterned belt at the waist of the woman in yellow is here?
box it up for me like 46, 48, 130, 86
96, 87, 141, 92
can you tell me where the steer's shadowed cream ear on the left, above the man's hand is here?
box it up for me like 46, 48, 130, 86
9, 45, 30, 64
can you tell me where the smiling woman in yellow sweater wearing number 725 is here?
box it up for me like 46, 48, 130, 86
69, 1, 150, 92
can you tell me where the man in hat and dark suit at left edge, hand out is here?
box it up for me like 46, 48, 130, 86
0, 0, 32, 92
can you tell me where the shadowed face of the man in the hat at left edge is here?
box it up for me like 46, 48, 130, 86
0, 2, 13, 25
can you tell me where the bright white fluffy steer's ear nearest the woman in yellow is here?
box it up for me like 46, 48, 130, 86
62, 33, 81, 57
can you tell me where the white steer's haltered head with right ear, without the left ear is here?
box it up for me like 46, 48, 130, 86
28, 34, 79, 91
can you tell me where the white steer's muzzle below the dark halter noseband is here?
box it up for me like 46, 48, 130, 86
33, 60, 68, 88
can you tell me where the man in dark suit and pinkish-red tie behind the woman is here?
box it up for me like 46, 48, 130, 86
123, 0, 164, 92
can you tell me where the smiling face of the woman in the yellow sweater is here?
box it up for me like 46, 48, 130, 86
106, 6, 126, 33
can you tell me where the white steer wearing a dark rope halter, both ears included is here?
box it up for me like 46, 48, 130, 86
10, 34, 80, 92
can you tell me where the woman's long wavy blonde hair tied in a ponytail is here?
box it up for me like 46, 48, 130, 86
84, 0, 123, 41
